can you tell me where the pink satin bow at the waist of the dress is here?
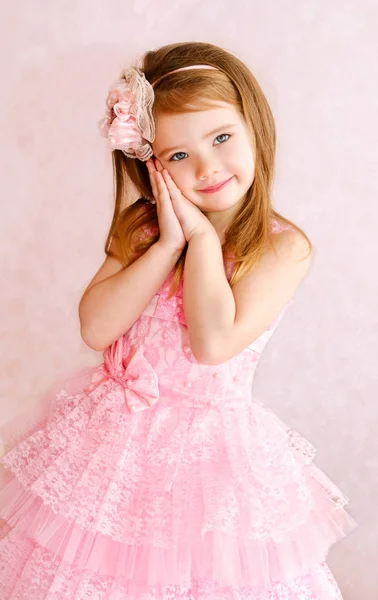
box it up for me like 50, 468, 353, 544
88, 337, 159, 412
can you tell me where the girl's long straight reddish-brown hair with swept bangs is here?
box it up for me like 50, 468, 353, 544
105, 42, 312, 294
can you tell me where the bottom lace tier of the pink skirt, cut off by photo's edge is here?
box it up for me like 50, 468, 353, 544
0, 531, 342, 600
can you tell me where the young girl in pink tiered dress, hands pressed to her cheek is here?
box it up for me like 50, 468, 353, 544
0, 43, 356, 600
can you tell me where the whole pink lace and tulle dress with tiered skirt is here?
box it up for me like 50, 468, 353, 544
0, 223, 356, 600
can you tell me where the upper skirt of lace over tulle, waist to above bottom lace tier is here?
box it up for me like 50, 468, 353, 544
0, 370, 356, 592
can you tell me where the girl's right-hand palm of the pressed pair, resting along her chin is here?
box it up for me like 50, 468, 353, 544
150, 158, 215, 242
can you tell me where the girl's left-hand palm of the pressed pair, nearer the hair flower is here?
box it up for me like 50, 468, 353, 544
146, 158, 186, 252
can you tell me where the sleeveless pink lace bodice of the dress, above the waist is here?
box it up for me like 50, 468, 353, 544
96, 219, 293, 406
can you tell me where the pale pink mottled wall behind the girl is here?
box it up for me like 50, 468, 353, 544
0, 0, 378, 600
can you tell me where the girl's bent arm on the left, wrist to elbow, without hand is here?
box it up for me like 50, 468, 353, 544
79, 241, 181, 351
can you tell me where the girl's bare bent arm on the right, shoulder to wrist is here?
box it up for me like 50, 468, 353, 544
184, 230, 312, 364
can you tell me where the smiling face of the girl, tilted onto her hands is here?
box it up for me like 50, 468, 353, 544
152, 102, 255, 221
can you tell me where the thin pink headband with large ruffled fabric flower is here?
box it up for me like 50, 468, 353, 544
98, 65, 219, 161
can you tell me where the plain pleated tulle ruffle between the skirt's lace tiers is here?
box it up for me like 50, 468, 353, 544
0, 480, 353, 591
